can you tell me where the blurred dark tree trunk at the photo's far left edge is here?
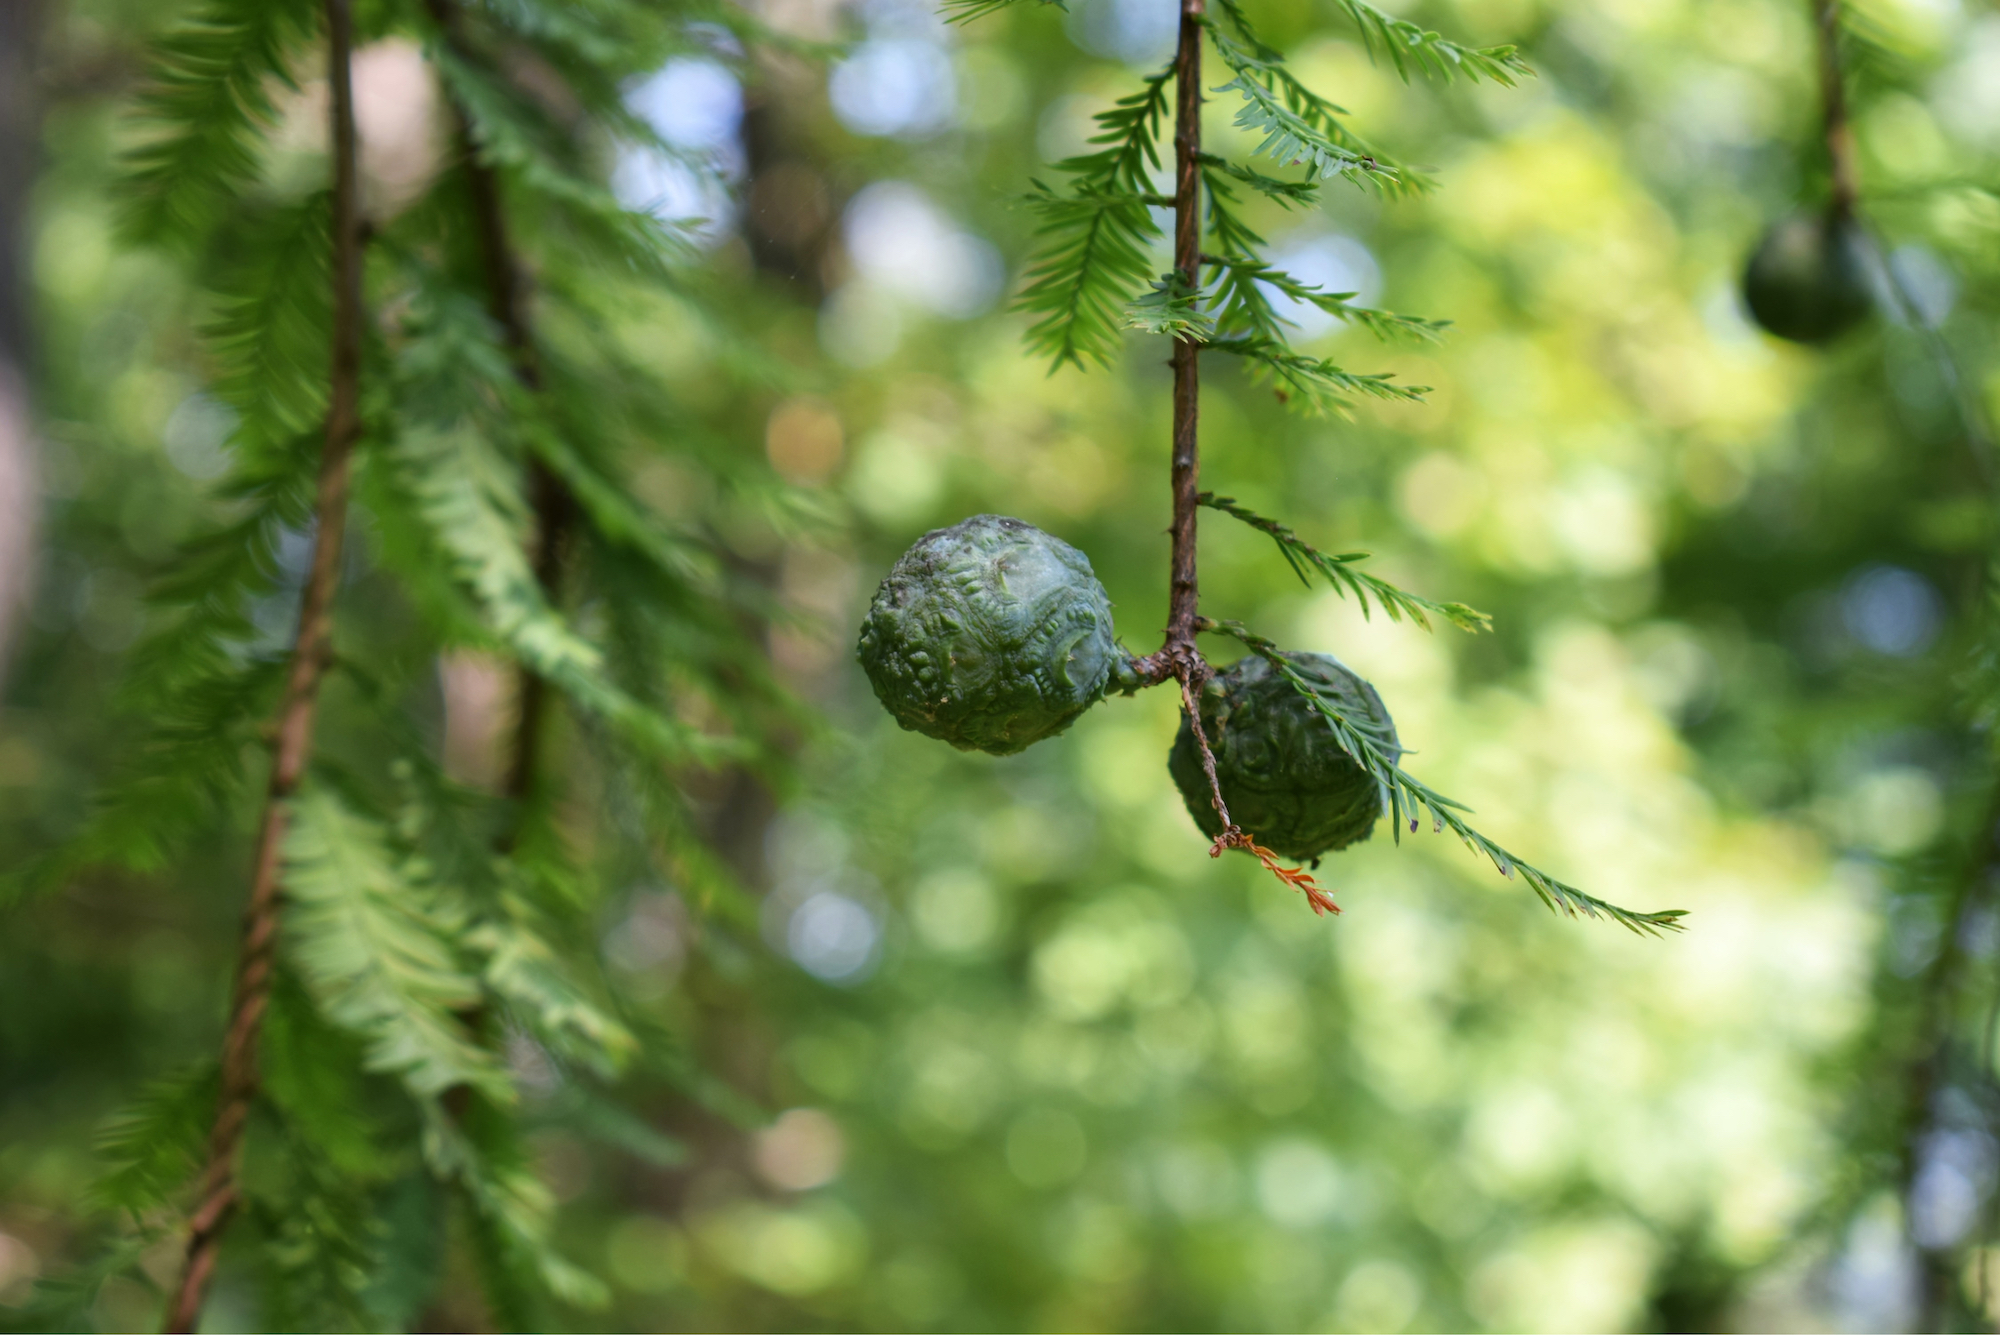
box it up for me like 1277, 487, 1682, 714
0, 0, 42, 681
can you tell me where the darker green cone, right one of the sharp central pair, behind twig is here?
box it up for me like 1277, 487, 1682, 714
1166, 654, 1402, 859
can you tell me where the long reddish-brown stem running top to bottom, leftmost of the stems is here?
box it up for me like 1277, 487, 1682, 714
166, 0, 362, 1331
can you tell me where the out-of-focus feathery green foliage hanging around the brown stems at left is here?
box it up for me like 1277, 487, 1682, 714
39, 0, 812, 1329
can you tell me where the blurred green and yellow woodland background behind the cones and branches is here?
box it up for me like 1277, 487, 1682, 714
0, 0, 2000, 1331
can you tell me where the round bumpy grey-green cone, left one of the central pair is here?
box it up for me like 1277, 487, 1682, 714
858, 514, 1124, 755
